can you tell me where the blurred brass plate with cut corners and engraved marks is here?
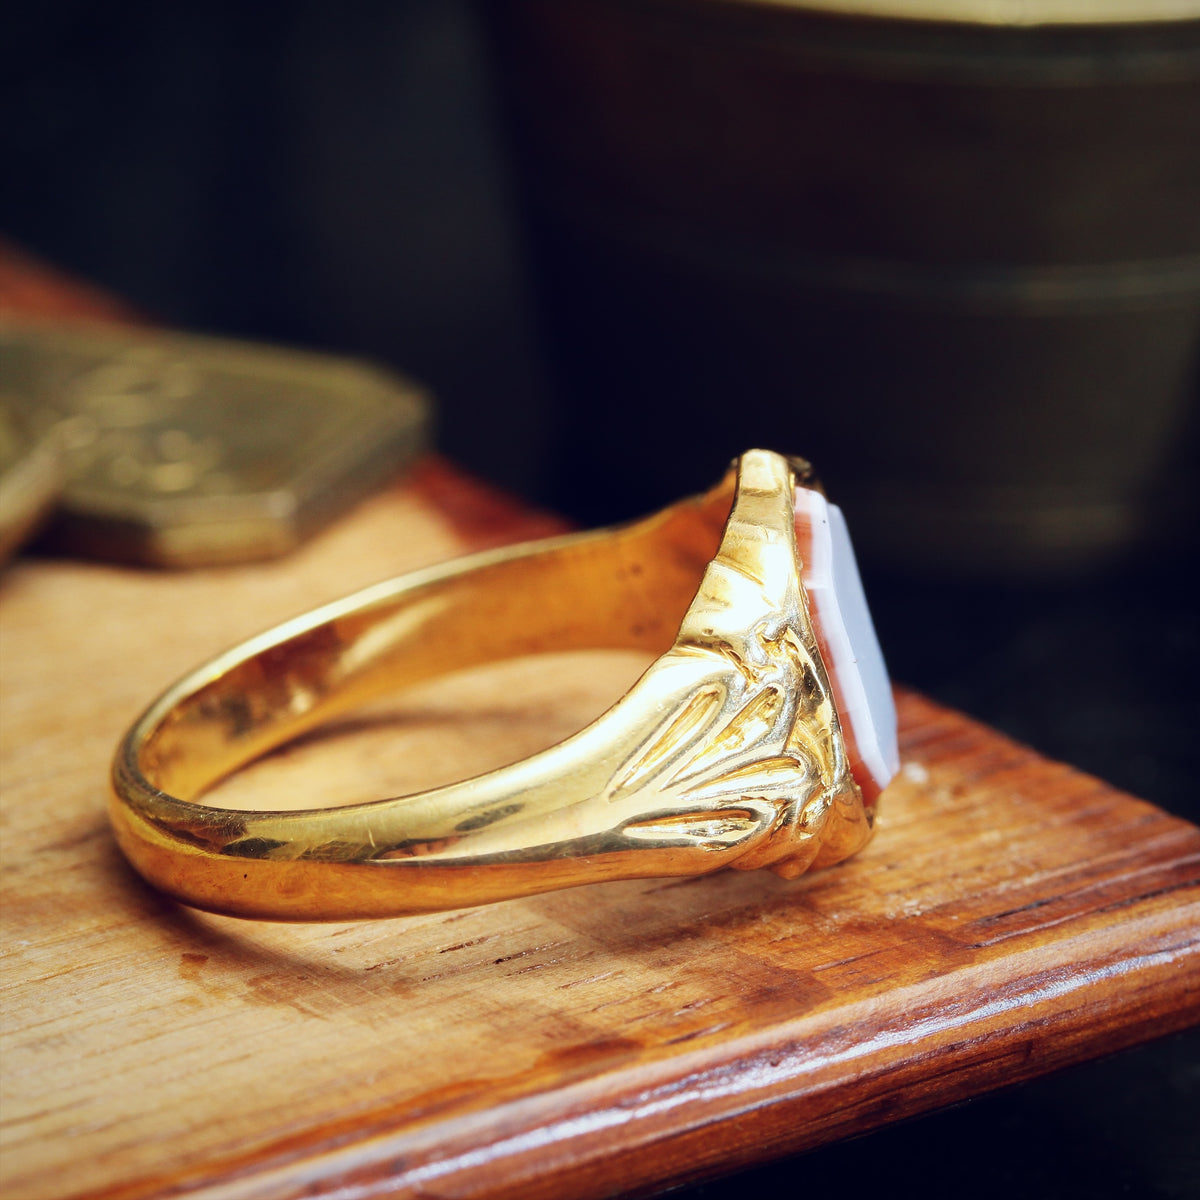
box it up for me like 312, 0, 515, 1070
0, 322, 427, 566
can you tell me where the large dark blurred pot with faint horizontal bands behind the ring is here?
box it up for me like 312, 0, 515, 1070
488, 0, 1200, 578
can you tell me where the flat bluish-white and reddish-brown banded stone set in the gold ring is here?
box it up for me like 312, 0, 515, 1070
796, 487, 900, 803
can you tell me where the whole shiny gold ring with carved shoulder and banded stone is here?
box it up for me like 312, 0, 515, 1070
110, 450, 898, 920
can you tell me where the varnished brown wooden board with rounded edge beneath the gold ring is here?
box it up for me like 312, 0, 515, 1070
0, 453, 1200, 1200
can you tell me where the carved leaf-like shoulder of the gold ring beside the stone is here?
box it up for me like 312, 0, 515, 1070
606, 460, 869, 878
